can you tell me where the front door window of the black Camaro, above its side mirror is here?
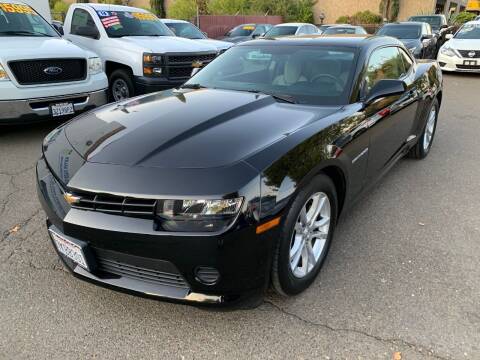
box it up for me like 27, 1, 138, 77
364, 47, 405, 92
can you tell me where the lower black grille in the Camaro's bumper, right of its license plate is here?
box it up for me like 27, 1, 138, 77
95, 250, 189, 289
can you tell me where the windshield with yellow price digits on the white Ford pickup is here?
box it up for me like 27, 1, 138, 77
0, 3, 58, 37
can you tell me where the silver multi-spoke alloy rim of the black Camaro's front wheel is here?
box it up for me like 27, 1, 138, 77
290, 192, 332, 278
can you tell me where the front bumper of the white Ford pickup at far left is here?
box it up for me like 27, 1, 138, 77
0, 89, 107, 125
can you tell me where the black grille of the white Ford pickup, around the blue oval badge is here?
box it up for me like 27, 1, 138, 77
8, 59, 87, 85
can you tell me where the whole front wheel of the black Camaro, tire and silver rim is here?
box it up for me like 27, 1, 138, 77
272, 175, 338, 295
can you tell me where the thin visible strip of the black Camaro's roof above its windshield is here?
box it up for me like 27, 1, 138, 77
237, 34, 402, 48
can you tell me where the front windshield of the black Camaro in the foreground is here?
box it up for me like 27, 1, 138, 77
185, 44, 356, 105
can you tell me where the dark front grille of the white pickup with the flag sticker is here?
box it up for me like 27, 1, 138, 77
165, 53, 217, 80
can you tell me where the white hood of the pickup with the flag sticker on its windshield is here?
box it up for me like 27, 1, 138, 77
111, 36, 217, 54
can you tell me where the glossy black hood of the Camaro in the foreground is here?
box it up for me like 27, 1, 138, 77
65, 89, 339, 168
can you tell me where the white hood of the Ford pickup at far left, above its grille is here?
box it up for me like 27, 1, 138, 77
0, 36, 87, 61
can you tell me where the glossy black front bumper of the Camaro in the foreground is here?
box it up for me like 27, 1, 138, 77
37, 159, 277, 304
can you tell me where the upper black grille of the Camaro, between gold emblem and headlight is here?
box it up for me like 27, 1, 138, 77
72, 193, 157, 218
